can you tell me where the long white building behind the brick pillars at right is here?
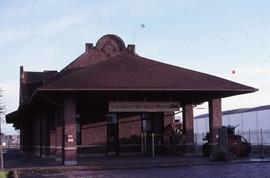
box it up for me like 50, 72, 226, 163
194, 105, 270, 145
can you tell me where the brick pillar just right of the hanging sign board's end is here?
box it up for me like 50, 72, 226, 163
183, 104, 194, 154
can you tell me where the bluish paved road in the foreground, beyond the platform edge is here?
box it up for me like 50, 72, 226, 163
23, 162, 270, 178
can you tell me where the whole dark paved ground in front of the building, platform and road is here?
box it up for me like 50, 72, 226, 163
4, 150, 270, 178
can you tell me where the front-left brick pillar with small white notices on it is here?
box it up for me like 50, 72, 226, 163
63, 97, 77, 165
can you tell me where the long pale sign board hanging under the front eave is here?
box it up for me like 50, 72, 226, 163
109, 101, 180, 112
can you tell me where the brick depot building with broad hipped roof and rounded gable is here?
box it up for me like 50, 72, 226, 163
7, 34, 256, 165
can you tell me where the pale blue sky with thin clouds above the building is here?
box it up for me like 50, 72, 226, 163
0, 0, 270, 133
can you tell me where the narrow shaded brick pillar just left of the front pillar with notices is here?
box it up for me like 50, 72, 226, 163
55, 109, 63, 161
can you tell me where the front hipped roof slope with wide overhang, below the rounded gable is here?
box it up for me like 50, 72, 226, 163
38, 52, 256, 94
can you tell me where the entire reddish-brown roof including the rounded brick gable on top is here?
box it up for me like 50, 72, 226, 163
7, 34, 257, 126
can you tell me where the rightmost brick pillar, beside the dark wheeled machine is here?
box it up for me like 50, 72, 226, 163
208, 98, 222, 156
